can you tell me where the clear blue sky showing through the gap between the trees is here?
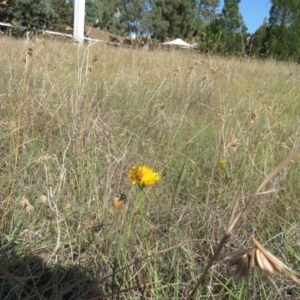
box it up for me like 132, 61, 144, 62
220, 0, 271, 33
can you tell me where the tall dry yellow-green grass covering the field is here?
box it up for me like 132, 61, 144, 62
0, 38, 300, 299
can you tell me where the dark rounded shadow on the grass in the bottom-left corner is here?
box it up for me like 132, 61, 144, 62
0, 242, 105, 300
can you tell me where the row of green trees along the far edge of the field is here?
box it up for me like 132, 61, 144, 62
0, 0, 300, 60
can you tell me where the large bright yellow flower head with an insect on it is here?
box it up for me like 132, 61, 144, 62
128, 166, 161, 187
